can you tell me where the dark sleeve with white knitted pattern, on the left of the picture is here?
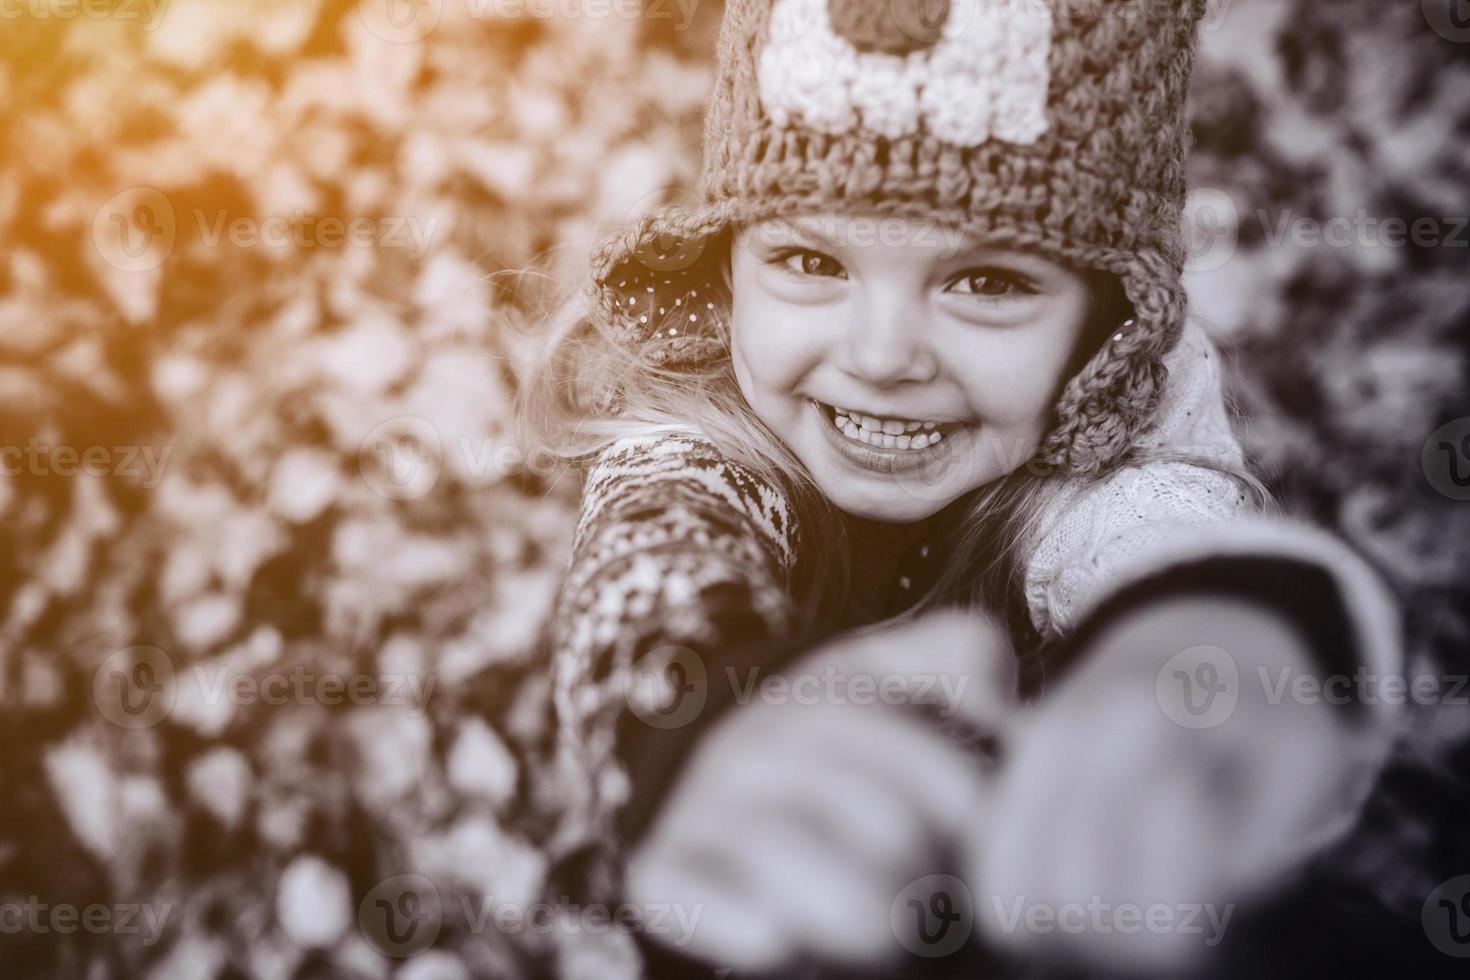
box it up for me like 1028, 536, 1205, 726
551, 432, 795, 852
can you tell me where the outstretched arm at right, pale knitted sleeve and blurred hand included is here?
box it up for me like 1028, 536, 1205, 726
993, 323, 1402, 970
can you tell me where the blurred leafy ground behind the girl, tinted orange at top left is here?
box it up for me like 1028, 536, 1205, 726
0, 0, 1470, 977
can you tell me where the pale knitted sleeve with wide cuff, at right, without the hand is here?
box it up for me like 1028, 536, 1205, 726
1025, 323, 1402, 696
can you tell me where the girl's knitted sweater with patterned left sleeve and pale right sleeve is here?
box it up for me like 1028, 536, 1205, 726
553, 326, 1399, 899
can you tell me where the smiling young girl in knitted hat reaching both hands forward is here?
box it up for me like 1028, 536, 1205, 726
522, 0, 1398, 973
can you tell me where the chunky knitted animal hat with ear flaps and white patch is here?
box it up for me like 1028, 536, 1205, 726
591, 0, 1207, 473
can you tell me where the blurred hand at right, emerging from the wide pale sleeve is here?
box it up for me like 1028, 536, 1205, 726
970, 598, 1361, 970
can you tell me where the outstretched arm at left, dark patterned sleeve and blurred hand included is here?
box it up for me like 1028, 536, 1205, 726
554, 435, 1011, 976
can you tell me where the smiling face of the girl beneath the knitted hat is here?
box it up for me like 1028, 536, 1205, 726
731, 216, 1092, 522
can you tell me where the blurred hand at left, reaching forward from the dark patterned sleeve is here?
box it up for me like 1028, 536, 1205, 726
628, 613, 1011, 970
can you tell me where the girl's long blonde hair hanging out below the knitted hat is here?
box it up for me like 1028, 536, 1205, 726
516, 232, 1269, 649
